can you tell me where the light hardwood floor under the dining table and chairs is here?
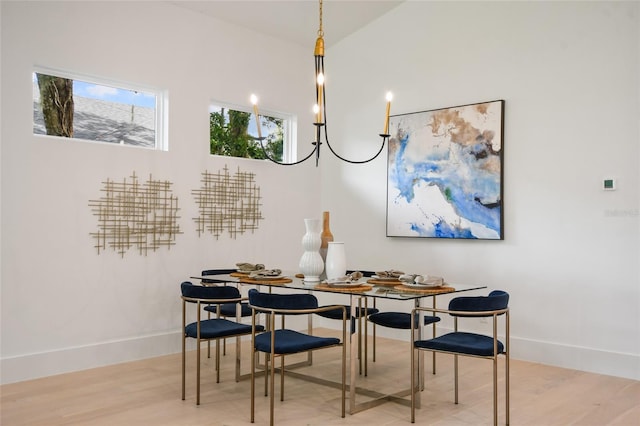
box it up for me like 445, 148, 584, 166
0, 337, 640, 426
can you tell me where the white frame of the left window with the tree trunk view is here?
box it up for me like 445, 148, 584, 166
31, 65, 169, 151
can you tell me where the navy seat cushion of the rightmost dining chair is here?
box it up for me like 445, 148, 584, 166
414, 332, 504, 356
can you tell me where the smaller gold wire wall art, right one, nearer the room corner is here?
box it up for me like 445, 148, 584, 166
192, 165, 264, 240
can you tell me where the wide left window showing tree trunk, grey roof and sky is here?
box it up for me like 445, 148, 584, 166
33, 69, 167, 150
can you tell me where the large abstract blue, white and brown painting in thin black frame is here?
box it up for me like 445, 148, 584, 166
386, 99, 505, 240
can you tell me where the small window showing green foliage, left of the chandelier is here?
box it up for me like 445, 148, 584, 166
209, 102, 295, 161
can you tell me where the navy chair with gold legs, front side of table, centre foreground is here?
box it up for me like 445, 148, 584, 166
249, 289, 347, 425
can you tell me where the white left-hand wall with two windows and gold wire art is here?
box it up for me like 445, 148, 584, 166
1, 2, 321, 382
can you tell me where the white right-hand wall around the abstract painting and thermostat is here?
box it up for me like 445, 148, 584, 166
322, 1, 640, 379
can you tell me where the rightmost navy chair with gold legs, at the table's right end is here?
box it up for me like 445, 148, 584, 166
411, 290, 509, 425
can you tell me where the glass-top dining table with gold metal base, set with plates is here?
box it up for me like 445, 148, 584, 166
191, 272, 487, 414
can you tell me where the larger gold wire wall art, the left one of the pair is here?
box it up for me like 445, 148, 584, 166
89, 172, 182, 257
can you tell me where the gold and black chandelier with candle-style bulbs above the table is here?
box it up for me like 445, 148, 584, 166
251, 0, 392, 167
